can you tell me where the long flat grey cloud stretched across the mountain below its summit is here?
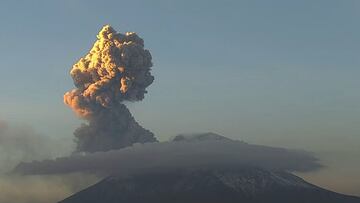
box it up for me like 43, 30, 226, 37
14, 140, 320, 176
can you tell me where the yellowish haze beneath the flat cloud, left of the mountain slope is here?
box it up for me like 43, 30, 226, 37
0, 174, 99, 203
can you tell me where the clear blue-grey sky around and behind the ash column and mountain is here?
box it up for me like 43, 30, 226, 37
0, 0, 360, 195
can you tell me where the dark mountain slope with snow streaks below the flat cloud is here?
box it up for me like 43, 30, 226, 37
60, 168, 360, 203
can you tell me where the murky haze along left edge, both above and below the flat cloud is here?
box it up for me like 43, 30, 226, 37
0, 120, 95, 203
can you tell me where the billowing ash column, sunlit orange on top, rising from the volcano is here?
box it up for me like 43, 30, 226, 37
64, 25, 156, 152
